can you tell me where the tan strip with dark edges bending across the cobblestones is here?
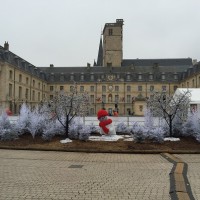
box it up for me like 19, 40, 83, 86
161, 153, 195, 200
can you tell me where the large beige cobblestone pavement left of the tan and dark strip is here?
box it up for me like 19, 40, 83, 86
0, 150, 172, 200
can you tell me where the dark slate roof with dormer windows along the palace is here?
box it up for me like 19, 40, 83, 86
0, 46, 197, 83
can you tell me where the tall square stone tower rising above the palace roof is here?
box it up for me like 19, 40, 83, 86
103, 19, 124, 67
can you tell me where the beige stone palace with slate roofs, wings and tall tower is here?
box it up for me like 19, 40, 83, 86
0, 19, 200, 116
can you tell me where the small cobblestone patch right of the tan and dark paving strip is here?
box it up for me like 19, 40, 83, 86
174, 154, 200, 200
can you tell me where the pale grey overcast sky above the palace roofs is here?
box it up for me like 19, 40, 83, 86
0, 0, 200, 67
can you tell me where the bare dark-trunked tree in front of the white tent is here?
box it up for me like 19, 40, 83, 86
147, 90, 191, 137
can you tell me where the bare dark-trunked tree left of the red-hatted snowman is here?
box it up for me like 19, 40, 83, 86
49, 83, 89, 137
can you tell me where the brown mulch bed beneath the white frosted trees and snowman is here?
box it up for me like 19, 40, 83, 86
0, 134, 200, 153
